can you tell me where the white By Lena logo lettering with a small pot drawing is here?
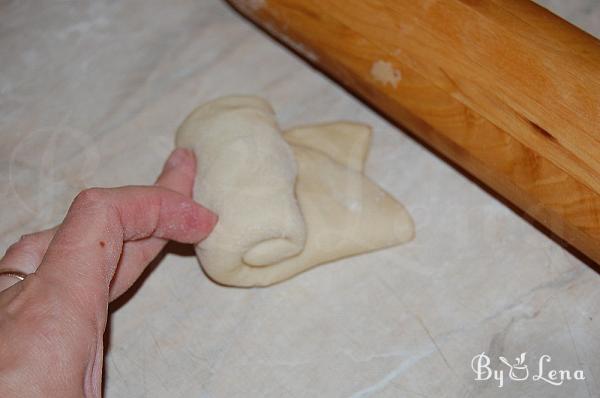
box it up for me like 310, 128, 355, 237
471, 352, 585, 388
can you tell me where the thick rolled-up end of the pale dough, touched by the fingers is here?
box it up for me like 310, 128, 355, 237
177, 97, 306, 270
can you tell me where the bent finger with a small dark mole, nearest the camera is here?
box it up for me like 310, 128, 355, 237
36, 186, 216, 313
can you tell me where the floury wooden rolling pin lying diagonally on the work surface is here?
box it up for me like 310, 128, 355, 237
230, 0, 600, 263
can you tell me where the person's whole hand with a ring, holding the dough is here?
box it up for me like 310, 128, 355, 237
0, 149, 217, 397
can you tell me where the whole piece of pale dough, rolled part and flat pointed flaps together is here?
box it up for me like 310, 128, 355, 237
177, 97, 414, 286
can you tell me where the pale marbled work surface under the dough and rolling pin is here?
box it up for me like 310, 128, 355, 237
0, 0, 600, 398
